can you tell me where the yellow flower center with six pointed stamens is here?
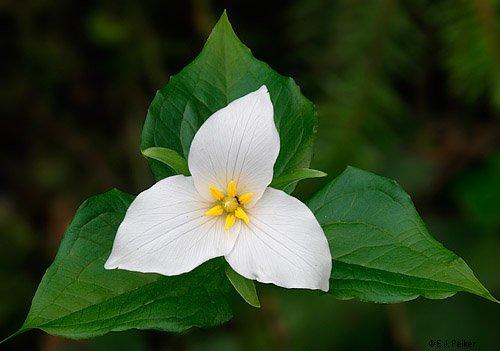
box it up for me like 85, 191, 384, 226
205, 180, 253, 230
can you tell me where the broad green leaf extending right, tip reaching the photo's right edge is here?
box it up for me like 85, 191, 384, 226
309, 167, 498, 303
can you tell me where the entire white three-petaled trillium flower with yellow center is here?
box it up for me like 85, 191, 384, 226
105, 86, 332, 291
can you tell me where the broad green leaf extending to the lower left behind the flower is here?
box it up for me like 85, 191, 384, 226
15, 190, 232, 338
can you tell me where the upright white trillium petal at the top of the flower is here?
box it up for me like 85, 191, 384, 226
188, 86, 280, 207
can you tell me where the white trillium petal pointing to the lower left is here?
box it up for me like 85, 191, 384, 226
104, 175, 239, 275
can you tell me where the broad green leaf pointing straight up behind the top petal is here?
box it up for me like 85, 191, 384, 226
141, 13, 316, 186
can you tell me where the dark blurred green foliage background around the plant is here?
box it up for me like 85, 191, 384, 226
0, 0, 500, 351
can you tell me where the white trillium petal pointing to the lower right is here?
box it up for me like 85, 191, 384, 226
226, 188, 332, 291
